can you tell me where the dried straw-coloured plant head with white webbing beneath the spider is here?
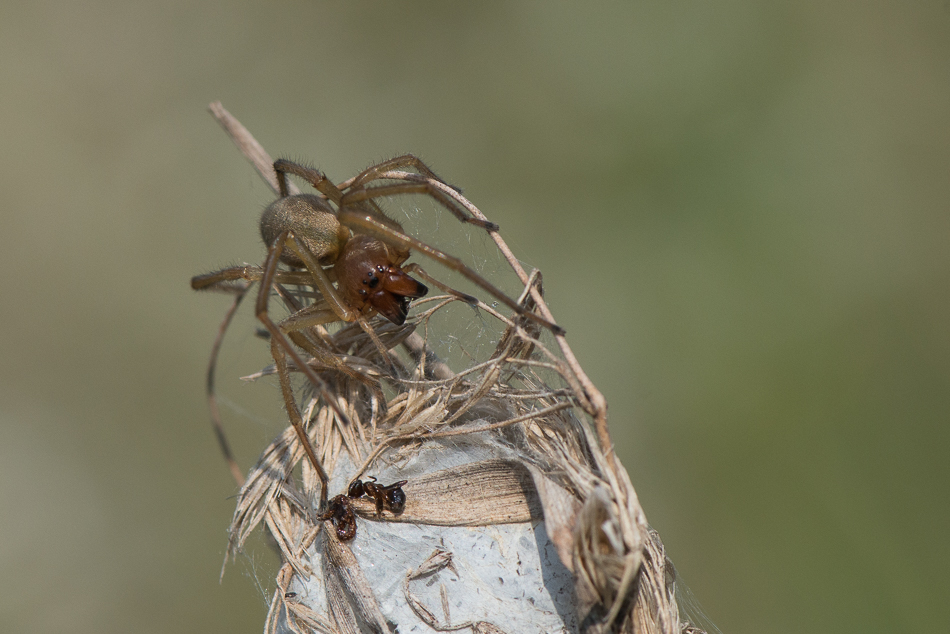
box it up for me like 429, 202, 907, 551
201, 103, 701, 634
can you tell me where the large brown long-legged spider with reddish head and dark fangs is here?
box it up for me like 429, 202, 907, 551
191, 154, 564, 506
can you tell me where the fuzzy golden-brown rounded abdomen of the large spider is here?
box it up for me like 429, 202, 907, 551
261, 194, 349, 267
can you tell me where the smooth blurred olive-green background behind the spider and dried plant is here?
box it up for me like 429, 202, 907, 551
0, 0, 950, 633
